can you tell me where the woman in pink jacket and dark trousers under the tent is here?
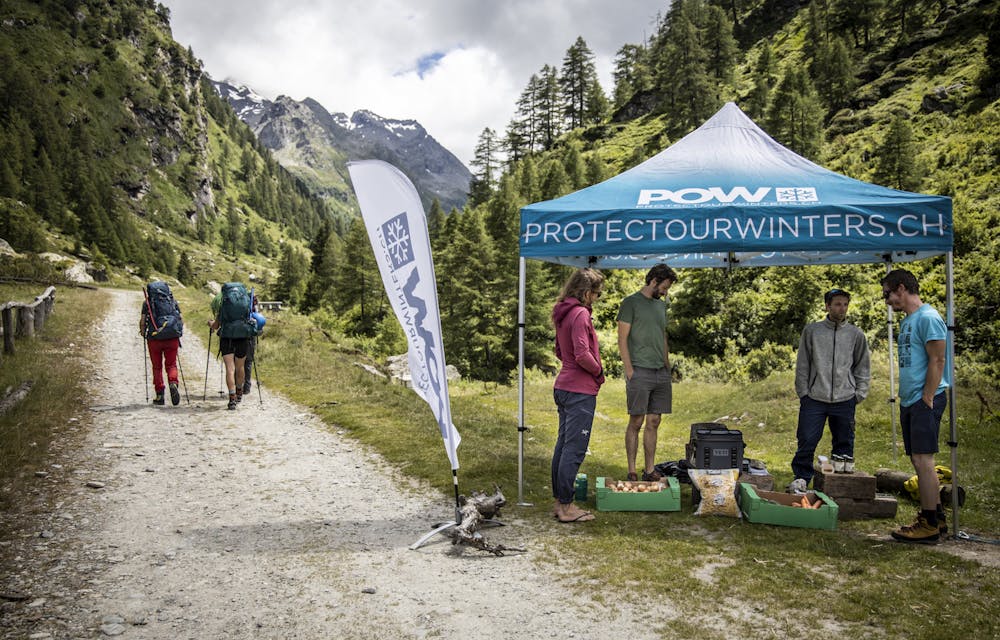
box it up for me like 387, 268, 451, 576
552, 269, 604, 522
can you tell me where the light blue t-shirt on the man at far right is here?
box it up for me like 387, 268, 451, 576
897, 304, 949, 407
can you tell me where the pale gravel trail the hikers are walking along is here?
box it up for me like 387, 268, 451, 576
0, 291, 676, 640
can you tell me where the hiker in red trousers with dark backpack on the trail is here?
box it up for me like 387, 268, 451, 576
139, 280, 184, 406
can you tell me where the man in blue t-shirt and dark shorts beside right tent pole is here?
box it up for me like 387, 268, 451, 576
882, 269, 950, 543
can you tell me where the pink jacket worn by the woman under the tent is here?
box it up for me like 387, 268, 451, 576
552, 298, 604, 396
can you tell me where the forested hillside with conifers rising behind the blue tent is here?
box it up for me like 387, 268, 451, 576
408, 0, 1000, 380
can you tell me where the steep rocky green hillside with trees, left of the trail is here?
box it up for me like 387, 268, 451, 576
0, 0, 330, 290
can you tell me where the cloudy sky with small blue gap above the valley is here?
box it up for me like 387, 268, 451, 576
161, 0, 669, 164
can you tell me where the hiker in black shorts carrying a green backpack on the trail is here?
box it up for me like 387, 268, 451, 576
208, 282, 258, 410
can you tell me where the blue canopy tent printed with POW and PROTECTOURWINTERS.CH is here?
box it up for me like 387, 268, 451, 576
518, 102, 958, 531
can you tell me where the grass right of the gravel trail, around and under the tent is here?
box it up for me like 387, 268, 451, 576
168, 292, 1000, 638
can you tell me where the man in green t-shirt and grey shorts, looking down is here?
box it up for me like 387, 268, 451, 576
618, 263, 677, 480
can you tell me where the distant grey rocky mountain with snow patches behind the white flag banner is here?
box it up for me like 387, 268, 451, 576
213, 82, 472, 212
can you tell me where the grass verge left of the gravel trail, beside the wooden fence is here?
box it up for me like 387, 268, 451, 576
0, 283, 108, 506
